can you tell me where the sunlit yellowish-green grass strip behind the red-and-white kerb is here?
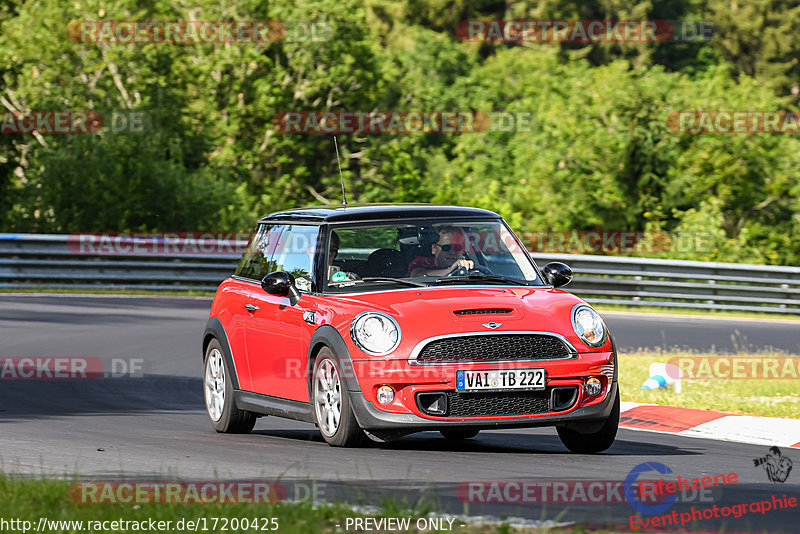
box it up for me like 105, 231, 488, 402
619, 351, 800, 419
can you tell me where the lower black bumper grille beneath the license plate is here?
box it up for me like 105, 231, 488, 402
417, 386, 578, 417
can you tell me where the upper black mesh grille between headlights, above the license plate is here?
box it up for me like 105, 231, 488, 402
416, 334, 571, 363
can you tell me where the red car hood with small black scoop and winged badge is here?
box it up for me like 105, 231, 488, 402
318, 286, 610, 353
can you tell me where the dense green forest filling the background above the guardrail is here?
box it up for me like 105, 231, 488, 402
0, 0, 800, 265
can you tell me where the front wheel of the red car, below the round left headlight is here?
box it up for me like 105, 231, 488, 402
311, 347, 367, 447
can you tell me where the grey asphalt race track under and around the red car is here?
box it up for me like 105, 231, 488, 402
0, 295, 800, 532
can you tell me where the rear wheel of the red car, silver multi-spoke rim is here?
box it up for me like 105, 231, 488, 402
203, 339, 256, 434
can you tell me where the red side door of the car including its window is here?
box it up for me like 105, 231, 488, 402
247, 225, 319, 401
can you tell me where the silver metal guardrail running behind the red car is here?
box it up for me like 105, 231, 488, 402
0, 234, 800, 315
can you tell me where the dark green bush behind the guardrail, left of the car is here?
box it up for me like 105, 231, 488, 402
15, 132, 255, 233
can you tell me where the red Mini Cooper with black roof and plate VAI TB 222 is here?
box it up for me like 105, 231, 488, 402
203, 205, 619, 453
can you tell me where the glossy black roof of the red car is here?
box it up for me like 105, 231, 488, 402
259, 204, 500, 223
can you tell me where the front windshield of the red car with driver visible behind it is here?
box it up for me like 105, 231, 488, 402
324, 220, 543, 292
